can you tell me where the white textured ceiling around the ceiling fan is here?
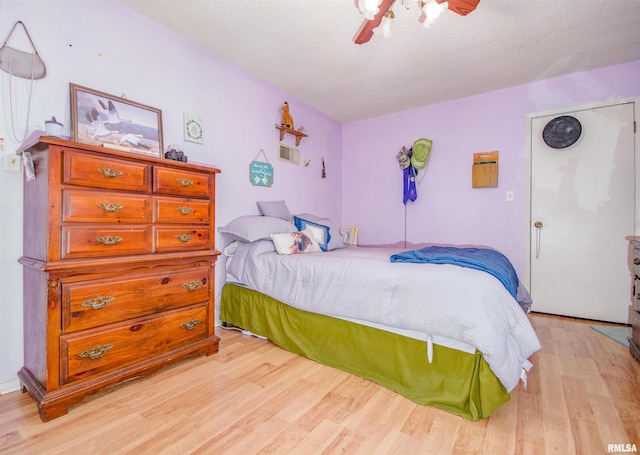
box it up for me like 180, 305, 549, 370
120, 0, 640, 123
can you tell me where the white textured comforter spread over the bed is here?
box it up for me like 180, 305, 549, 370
227, 240, 540, 392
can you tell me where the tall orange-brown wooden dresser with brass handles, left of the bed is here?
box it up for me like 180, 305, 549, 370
18, 137, 220, 421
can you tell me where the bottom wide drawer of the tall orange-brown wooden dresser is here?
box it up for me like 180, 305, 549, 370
60, 304, 207, 384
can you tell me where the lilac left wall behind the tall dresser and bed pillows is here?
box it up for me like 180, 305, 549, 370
0, 0, 342, 390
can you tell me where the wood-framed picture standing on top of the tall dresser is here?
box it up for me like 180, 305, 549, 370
69, 83, 164, 157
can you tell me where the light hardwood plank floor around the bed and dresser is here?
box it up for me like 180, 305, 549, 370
0, 315, 640, 455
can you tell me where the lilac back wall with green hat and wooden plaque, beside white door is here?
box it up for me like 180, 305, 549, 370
342, 61, 640, 275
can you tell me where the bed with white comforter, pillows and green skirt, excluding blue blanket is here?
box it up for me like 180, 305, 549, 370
220, 216, 540, 421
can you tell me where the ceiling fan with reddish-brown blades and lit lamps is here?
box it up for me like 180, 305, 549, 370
353, 0, 480, 44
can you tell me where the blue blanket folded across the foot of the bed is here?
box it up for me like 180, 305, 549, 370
391, 246, 518, 299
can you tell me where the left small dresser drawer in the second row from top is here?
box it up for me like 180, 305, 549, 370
62, 189, 149, 223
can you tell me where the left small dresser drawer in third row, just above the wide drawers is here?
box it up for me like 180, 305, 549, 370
62, 225, 151, 259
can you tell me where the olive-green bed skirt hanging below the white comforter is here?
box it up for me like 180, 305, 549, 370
220, 284, 509, 421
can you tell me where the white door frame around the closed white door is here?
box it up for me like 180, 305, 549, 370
523, 96, 640, 291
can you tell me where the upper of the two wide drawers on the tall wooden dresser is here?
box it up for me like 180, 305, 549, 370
62, 266, 211, 333
